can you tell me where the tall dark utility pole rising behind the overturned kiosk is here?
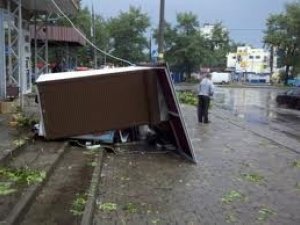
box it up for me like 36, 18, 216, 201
158, 0, 165, 62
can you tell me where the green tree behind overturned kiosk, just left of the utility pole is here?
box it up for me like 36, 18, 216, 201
107, 6, 150, 63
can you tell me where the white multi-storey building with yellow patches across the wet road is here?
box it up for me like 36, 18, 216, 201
227, 46, 277, 74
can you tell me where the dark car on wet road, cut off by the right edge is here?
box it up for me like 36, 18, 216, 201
276, 87, 300, 110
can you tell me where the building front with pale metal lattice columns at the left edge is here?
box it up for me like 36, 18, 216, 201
0, 0, 79, 100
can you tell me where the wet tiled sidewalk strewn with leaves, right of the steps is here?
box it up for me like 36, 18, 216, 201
94, 106, 300, 225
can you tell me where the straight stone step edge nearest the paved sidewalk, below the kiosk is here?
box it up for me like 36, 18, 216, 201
80, 150, 105, 225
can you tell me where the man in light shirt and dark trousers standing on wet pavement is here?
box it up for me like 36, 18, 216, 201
198, 74, 214, 123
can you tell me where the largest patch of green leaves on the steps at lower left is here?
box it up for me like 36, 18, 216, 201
0, 168, 46, 185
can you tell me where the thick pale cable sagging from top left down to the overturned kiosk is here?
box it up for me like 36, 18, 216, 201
51, 0, 134, 66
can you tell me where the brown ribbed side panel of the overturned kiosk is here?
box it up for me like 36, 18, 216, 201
38, 71, 159, 139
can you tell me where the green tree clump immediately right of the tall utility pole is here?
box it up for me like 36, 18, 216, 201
154, 12, 230, 78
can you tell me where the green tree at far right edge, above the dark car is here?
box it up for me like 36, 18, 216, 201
264, 1, 300, 84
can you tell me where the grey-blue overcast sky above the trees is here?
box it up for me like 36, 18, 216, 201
82, 0, 292, 47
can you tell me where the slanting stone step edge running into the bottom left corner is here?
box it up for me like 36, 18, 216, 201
0, 142, 68, 225
